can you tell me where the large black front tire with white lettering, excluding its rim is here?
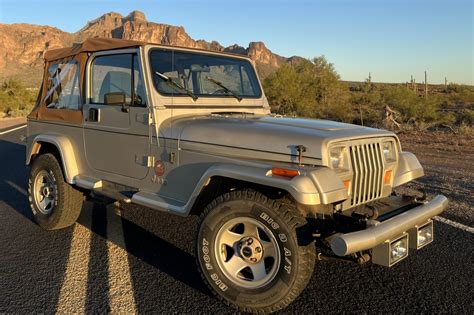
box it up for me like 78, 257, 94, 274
196, 190, 316, 313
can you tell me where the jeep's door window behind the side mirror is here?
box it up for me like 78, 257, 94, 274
91, 53, 146, 106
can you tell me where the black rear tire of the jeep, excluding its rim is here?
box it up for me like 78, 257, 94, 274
28, 153, 84, 230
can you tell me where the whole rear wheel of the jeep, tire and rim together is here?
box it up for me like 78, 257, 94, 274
28, 153, 84, 230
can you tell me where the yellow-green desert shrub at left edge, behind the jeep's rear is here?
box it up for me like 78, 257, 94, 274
0, 78, 38, 116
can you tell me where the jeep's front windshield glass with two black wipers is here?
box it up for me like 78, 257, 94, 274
150, 49, 262, 99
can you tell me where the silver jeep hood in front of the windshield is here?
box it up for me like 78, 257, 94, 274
165, 114, 395, 164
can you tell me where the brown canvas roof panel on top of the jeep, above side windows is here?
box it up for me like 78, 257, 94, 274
44, 38, 147, 61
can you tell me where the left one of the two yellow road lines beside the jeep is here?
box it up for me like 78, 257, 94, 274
56, 224, 92, 313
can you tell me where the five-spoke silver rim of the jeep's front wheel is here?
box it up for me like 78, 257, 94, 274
215, 217, 280, 289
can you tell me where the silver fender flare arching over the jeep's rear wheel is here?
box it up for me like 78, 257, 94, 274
26, 135, 79, 184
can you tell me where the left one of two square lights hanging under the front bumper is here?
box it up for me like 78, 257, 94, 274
372, 233, 408, 267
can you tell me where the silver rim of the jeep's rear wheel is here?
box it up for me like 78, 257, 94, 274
33, 170, 57, 214
